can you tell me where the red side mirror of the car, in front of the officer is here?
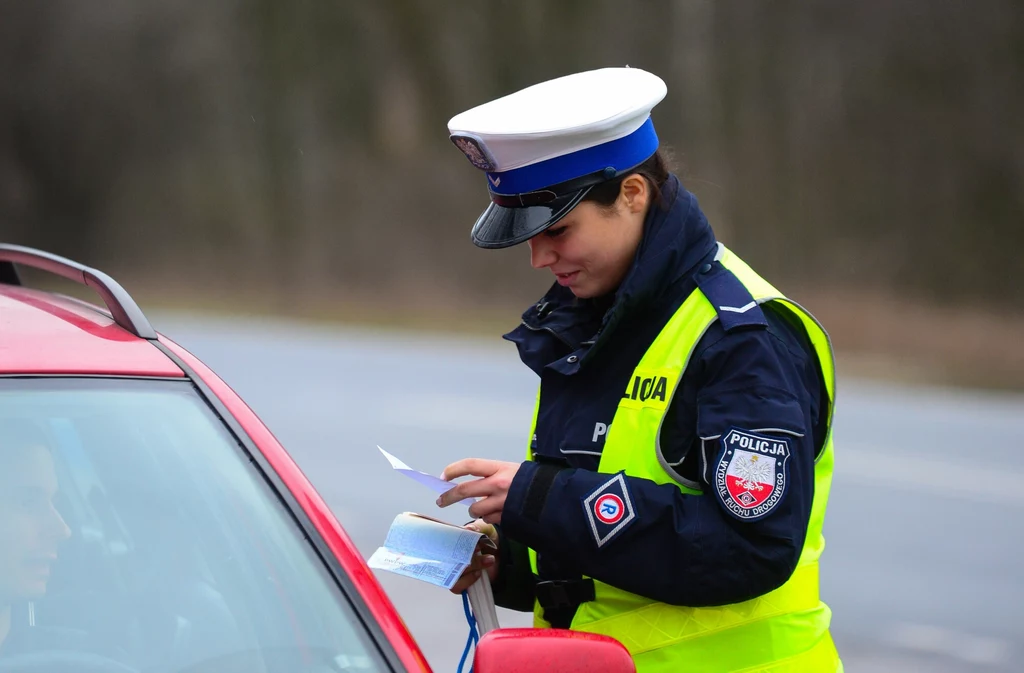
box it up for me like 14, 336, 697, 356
473, 629, 637, 673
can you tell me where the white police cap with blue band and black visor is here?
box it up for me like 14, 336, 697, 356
449, 68, 667, 248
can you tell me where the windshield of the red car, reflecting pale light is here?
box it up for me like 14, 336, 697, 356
0, 379, 388, 673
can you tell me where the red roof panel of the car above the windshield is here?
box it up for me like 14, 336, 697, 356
0, 284, 184, 378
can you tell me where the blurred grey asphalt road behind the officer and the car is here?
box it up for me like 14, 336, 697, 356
153, 313, 1024, 673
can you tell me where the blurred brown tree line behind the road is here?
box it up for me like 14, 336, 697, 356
0, 0, 1024, 308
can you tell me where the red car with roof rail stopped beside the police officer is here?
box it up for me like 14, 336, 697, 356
0, 245, 634, 673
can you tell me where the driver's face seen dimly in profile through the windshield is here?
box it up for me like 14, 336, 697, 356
0, 447, 71, 600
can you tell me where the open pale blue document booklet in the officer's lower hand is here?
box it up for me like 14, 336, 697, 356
367, 512, 493, 589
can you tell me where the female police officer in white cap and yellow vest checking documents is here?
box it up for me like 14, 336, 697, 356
438, 68, 842, 671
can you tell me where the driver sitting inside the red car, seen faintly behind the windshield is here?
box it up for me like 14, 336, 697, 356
0, 419, 71, 661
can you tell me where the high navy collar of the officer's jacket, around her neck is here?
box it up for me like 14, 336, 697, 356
505, 175, 717, 372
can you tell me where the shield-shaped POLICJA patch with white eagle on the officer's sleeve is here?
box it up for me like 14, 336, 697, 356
714, 427, 792, 521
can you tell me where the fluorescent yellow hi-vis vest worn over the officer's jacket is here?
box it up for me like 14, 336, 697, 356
527, 247, 843, 673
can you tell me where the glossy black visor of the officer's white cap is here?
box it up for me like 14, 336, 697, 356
473, 185, 593, 249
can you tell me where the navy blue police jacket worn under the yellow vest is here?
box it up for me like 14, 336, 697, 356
496, 176, 828, 626
